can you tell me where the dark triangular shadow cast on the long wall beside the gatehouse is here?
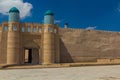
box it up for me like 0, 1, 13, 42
60, 39, 74, 63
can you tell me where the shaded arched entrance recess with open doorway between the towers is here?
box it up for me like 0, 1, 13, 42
23, 41, 41, 64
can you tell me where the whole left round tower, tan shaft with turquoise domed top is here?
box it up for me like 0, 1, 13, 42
7, 7, 20, 64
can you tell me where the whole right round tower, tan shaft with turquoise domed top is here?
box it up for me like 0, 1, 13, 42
42, 10, 55, 64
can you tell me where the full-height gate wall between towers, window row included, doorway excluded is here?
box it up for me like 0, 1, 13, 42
20, 23, 42, 64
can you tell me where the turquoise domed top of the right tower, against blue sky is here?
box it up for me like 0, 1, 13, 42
44, 10, 54, 24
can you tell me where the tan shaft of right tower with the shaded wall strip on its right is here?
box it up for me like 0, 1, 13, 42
42, 24, 59, 64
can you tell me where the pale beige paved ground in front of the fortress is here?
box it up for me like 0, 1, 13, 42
0, 65, 120, 80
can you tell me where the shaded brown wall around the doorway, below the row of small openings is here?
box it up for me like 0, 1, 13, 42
20, 33, 42, 64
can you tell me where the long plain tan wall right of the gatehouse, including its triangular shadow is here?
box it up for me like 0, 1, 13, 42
59, 28, 120, 62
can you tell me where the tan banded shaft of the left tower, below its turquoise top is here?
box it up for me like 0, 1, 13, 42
7, 22, 21, 64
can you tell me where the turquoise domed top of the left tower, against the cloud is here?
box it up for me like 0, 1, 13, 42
9, 7, 20, 22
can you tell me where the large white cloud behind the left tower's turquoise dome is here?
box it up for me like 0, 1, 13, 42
0, 0, 33, 18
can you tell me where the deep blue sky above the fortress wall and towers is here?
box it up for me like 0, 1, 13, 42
0, 0, 120, 31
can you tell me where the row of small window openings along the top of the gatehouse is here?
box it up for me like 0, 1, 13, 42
1, 22, 58, 34
